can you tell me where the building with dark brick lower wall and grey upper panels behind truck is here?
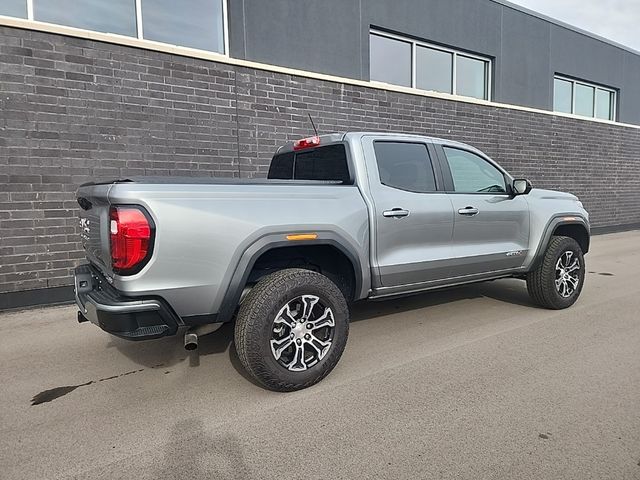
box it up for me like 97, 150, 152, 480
0, 0, 640, 308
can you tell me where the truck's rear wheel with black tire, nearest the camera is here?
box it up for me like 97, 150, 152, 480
235, 268, 349, 392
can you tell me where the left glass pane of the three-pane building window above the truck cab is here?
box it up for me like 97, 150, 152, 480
369, 35, 411, 87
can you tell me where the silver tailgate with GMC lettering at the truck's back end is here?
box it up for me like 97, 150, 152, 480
76, 184, 112, 273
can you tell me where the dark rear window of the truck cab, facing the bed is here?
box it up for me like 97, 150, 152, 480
267, 144, 350, 183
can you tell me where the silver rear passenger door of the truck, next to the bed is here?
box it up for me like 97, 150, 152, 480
363, 136, 453, 287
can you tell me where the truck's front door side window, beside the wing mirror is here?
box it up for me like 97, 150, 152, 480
443, 147, 507, 193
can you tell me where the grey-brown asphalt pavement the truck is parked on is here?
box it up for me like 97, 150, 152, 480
0, 232, 640, 480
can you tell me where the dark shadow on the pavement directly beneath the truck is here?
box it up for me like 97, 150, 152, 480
107, 279, 539, 378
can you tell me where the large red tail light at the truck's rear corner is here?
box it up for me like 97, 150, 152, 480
109, 206, 154, 274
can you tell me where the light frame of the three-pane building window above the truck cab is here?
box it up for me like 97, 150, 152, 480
369, 28, 493, 102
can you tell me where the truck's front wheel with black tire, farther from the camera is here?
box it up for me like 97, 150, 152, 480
527, 236, 585, 310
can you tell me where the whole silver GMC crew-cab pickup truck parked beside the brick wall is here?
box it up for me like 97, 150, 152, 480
75, 132, 590, 391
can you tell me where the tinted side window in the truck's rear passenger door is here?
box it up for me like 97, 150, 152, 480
373, 142, 436, 193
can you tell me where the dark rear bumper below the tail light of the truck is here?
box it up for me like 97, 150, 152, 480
75, 265, 182, 340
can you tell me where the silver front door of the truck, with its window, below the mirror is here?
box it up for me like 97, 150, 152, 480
435, 144, 529, 277
